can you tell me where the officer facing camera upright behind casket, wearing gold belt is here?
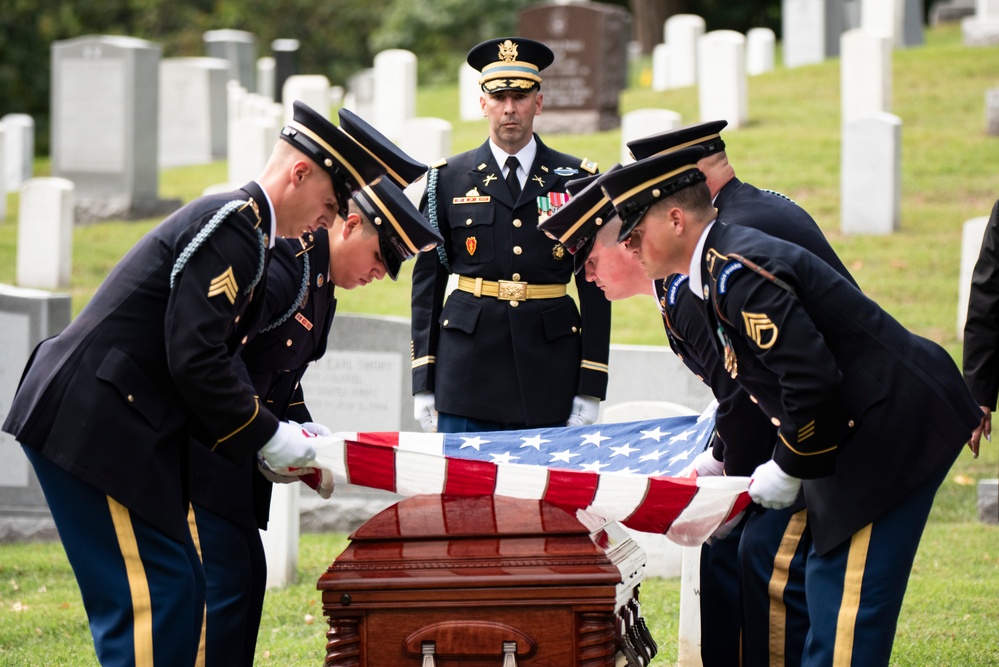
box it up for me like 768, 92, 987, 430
412, 37, 611, 432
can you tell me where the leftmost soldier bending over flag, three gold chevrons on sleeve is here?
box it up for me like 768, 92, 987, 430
3, 103, 383, 666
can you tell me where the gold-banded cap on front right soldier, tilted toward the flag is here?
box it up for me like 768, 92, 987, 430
599, 146, 705, 242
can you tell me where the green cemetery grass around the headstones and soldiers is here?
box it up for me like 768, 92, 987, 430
0, 20, 999, 667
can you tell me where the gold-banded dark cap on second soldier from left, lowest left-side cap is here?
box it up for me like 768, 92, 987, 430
354, 178, 444, 280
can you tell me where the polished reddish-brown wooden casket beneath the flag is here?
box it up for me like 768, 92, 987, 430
317, 495, 656, 667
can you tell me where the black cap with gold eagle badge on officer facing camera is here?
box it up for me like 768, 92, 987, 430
465, 37, 555, 93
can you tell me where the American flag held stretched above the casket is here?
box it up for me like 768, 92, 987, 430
316, 413, 749, 546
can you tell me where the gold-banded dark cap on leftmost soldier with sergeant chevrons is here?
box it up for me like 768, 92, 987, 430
281, 100, 388, 214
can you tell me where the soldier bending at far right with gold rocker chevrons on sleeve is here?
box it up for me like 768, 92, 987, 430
601, 147, 981, 666
